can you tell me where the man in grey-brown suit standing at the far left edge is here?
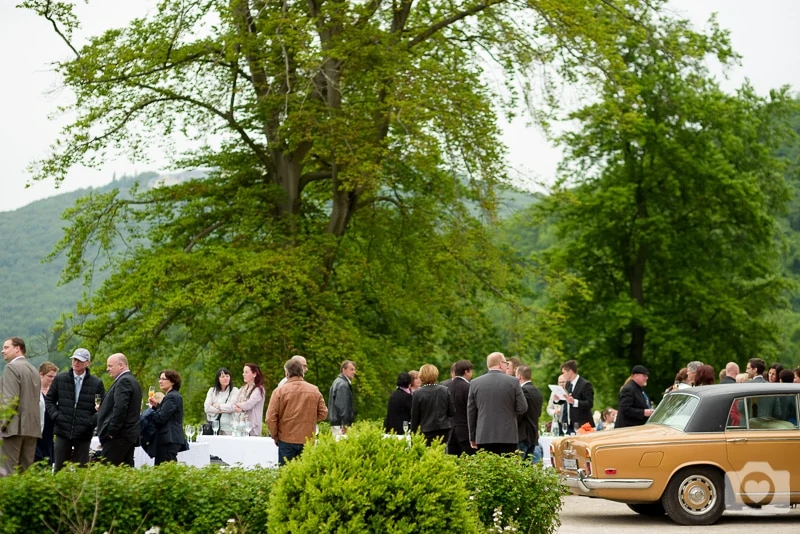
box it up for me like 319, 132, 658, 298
0, 337, 42, 476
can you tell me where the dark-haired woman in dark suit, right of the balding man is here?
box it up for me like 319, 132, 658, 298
149, 369, 186, 465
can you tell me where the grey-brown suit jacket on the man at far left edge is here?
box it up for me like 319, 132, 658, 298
0, 358, 42, 438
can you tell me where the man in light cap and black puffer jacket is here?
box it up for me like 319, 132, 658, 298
44, 348, 105, 471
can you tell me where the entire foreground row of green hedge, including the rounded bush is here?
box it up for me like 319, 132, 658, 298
0, 423, 565, 534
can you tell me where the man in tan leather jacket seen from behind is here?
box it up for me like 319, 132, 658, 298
267, 359, 328, 465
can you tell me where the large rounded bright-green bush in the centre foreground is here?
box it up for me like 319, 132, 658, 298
269, 423, 477, 534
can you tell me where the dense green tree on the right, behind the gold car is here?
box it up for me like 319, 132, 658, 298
542, 13, 792, 397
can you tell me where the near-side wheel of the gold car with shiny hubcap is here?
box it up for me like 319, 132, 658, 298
661, 466, 725, 525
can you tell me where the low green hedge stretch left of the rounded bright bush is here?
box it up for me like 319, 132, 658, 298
0, 463, 276, 534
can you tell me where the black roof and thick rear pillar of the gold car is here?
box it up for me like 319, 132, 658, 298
665, 382, 800, 432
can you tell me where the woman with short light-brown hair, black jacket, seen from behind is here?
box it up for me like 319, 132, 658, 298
411, 363, 456, 445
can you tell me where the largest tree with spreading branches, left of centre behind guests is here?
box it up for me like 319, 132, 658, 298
24, 0, 662, 414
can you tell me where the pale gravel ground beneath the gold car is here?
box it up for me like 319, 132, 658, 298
558, 495, 800, 534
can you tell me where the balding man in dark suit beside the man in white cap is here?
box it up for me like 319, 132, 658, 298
97, 353, 142, 466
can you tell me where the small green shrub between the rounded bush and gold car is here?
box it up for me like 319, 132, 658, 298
458, 451, 567, 534
